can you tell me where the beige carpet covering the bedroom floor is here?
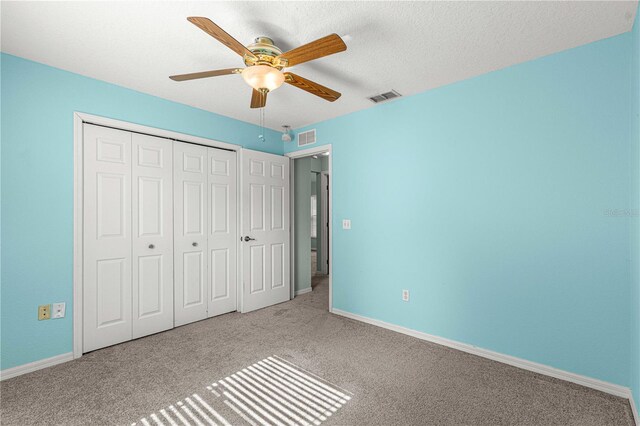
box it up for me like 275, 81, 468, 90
0, 275, 633, 426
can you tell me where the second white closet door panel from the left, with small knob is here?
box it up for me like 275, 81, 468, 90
131, 133, 173, 339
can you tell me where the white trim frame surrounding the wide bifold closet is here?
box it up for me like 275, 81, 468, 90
72, 111, 242, 359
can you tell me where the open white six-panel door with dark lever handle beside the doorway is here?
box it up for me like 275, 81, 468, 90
241, 149, 291, 312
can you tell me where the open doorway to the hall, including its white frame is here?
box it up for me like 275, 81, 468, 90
288, 146, 331, 310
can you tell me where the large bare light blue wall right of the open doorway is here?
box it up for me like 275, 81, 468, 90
285, 34, 637, 386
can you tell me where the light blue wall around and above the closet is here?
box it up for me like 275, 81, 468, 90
1, 54, 283, 369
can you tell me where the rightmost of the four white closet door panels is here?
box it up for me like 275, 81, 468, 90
207, 148, 238, 317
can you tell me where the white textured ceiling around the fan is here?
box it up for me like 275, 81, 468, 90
1, 1, 637, 128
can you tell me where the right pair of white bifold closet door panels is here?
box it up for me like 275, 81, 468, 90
173, 142, 237, 326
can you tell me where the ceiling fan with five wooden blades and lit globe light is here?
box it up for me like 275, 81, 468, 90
169, 16, 347, 108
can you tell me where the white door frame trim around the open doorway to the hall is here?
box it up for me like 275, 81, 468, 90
284, 144, 333, 312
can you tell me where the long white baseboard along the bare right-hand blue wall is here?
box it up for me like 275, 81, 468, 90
332, 308, 640, 418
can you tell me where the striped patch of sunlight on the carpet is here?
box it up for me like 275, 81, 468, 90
131, 355, 352, 426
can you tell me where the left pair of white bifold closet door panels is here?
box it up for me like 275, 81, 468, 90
83, 124, 173, 352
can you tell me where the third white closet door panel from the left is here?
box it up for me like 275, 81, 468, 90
173, 142, 209, 326
